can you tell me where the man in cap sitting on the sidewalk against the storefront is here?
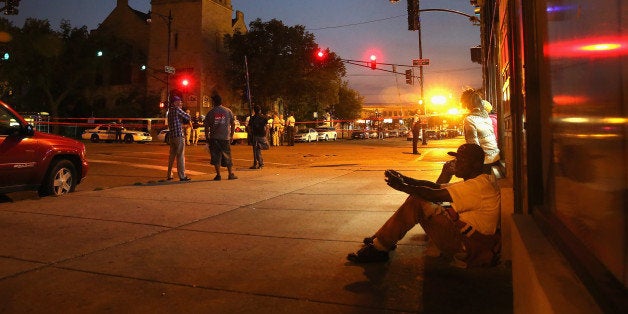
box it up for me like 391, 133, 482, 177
347, 144, 501, 267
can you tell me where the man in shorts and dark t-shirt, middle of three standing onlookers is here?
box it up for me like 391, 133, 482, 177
204, 93, 238, 181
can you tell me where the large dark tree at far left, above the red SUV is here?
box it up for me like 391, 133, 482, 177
0, 19, 98, 116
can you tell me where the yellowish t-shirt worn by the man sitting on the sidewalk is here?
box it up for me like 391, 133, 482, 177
445, 174, 501, 235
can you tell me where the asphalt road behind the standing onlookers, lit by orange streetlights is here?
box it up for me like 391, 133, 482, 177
0, 137, 463, 202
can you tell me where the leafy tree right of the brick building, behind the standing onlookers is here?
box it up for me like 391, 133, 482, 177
225, 19, 345, 120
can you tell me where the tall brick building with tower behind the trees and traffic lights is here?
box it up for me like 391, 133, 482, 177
94, 0, 247, 114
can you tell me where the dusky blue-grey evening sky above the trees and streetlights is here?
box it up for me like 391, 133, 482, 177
5, 0, 482, 103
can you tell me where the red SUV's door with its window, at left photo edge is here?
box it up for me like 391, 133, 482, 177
0, 107, 37, 188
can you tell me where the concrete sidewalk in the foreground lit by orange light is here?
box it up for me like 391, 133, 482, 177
0, 168, 512, 313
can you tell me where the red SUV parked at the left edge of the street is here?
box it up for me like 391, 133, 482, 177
0, 101, 88, 196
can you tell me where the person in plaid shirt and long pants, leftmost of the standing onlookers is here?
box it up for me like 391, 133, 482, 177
167, 96, 191, 181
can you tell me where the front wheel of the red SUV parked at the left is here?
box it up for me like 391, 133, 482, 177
39, 159, 77, 196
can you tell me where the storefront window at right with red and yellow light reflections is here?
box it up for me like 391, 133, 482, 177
543, 0, 628, 287
